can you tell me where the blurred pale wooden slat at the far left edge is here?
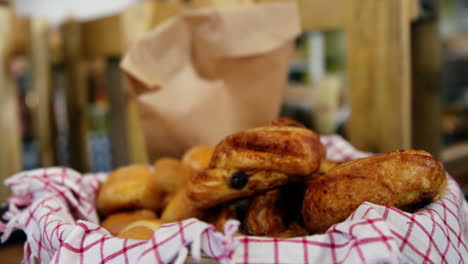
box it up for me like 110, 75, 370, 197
0, 6, 22, 201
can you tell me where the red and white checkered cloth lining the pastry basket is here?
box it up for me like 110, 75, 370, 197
0, 136, 468, 264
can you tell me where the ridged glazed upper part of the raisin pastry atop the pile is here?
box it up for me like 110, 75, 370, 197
210, 119, 325, 176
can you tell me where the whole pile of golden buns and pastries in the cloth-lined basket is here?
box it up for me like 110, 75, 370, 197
97, 118, 447, 240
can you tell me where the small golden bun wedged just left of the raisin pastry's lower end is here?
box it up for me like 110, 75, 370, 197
161, 188, 205, 222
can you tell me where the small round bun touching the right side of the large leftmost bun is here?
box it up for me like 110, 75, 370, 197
154, 158, 189, 193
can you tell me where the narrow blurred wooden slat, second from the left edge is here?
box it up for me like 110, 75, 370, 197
31, 18, 56, 167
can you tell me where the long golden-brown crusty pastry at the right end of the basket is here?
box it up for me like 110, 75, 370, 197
302, 150, 447, 232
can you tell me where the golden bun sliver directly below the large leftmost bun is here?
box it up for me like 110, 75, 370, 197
101, 209, 156, 236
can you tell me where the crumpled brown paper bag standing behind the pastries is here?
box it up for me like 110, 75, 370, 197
121, 3, 300, 160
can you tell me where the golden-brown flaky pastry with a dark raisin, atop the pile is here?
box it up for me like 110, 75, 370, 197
187, 119, 325, 208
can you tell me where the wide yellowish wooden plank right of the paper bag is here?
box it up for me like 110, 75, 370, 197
346, 0, 411, 152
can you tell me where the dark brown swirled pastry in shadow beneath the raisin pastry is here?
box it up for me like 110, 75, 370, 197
243, 189, 286, 236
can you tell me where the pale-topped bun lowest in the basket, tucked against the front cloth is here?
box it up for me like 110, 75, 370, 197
117, 219, 165, 240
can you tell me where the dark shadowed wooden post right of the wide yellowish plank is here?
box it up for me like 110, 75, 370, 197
411, 0, 442, 157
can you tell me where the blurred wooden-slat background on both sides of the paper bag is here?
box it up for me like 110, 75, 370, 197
0, 0, 468, 200
